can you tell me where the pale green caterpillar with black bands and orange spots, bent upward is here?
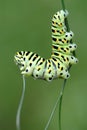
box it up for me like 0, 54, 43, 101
14, 10, 78, 81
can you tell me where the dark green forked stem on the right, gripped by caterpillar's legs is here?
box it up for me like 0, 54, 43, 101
44, 0, 76, 130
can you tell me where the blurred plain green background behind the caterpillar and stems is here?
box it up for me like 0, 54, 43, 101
0, 0, 87, 130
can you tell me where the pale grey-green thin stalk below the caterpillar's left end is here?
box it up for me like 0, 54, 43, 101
16, 75, 25, 130
